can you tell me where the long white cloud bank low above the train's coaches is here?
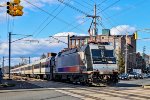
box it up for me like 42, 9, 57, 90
0, 32, 84, 56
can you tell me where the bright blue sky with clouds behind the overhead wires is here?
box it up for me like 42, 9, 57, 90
0, 0, 150, 65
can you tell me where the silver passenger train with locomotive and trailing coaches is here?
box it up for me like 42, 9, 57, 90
11, 42, 118, 85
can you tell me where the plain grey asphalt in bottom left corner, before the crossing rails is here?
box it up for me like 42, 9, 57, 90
0, 90, 79, 100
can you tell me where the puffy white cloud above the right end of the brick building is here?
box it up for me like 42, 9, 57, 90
110, 25, 136, 35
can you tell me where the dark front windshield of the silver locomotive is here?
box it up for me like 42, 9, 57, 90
92, 49, 116, 64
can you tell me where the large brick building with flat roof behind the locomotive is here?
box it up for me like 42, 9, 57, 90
69, 30, 136, 70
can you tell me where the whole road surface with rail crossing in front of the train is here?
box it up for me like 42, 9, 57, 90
0, 79, 150, 100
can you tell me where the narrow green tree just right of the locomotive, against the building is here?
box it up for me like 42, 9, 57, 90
118, 49, 125, 73
